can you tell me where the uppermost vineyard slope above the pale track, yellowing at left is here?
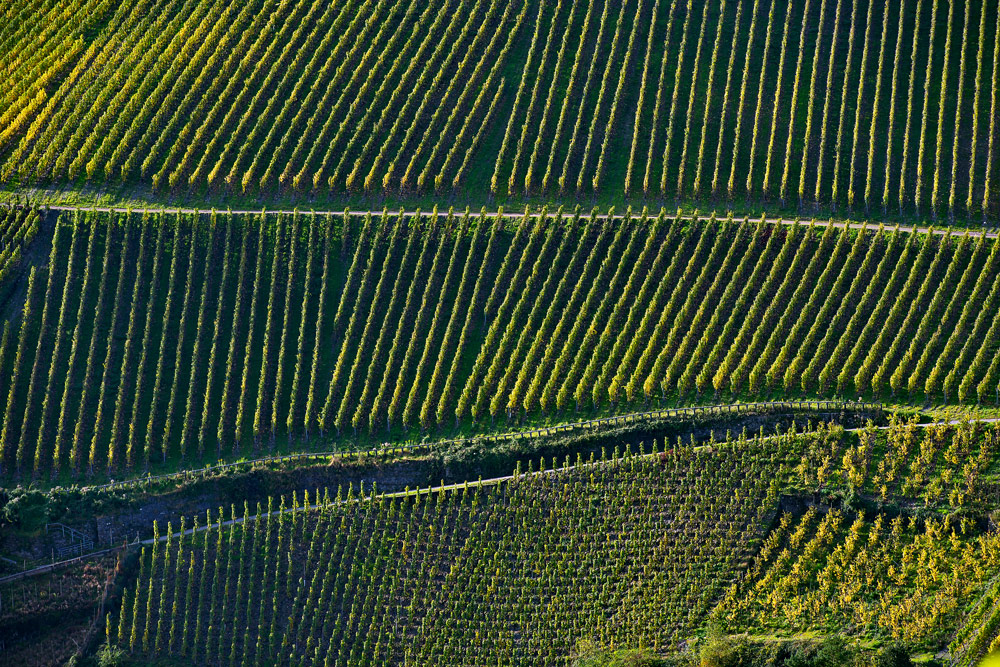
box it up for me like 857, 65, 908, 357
0, 0, 1000, 222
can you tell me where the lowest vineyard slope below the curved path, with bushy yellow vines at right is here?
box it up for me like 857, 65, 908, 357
108, 423, 998, 665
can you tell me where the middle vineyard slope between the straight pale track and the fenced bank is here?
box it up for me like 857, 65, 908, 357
0, 205, 1000, 476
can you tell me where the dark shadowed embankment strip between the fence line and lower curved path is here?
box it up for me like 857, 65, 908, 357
0, 409, 864, 560
